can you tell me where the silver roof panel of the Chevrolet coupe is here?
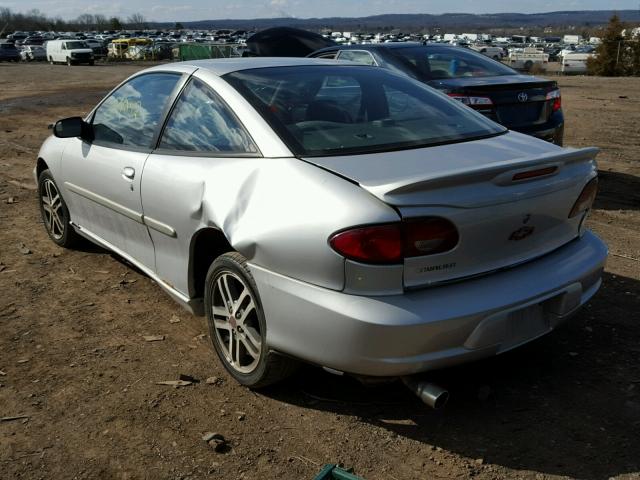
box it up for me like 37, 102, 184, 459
145, 57, 356, 76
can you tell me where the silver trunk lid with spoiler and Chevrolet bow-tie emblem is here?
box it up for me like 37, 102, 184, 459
305, 132, 598, 288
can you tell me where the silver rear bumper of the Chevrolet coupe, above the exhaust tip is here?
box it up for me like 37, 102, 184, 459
251, 231, 607, 376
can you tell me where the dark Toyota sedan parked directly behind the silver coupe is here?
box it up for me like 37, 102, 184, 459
310, 43, 564, 145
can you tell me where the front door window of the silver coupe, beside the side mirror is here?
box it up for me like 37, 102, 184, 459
93, 73, 180, 147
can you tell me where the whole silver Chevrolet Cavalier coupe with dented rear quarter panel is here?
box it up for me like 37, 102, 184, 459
34, 58, 607, 394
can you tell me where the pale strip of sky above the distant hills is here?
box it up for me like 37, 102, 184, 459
0, 0, 640, 22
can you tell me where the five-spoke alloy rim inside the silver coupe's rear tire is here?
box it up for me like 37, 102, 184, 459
211, 270, 262, 374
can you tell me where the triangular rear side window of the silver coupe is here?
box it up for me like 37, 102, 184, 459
160, 78, 258, 153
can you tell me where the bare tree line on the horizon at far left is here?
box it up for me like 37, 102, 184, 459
0, 8, 148, 37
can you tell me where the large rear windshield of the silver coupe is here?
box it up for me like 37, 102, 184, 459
224, 65, 506, 156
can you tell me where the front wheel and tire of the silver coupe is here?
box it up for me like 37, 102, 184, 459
38, 170, 81, 248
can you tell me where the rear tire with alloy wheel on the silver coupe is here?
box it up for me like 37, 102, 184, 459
204, 252, 297, 388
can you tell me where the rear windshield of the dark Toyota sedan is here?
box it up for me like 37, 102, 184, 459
391, 46, 517, 81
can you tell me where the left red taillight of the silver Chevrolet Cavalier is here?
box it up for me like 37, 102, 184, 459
329, 217, 459, 264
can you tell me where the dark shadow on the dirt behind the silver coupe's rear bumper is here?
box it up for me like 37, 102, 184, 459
264, 274, 640, 479
